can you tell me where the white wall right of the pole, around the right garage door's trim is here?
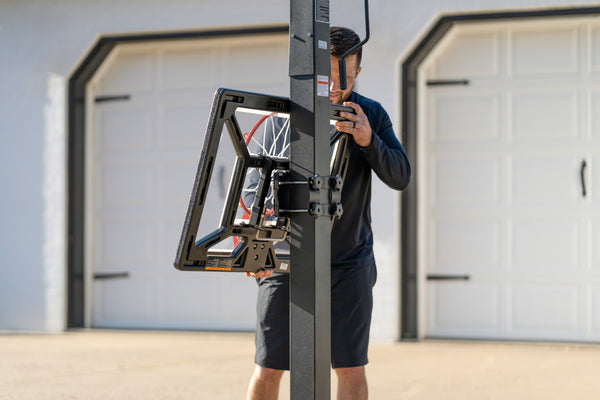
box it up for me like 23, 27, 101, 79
330, 0, 597, 342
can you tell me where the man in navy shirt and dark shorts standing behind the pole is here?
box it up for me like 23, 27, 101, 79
247, 27, 410, 400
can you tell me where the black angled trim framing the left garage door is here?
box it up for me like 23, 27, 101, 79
67, 24, 289, 328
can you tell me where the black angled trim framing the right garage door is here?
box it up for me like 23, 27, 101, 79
400, 7, 600, 340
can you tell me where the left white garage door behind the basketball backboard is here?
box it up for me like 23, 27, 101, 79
86, 35, 289, 330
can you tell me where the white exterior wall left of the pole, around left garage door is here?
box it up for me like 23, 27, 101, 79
0, 0, 289, 332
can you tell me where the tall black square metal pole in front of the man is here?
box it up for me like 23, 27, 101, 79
290, 0, 331, 400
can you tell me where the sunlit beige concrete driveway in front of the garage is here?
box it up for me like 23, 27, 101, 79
0, 330, 600, 400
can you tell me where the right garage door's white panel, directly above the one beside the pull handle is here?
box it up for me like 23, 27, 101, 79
510, 90, 578, 139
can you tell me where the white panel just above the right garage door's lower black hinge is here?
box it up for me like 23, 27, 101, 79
432, 220, 500, 273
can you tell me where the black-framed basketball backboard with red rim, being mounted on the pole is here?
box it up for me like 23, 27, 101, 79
175, 89, 354, 272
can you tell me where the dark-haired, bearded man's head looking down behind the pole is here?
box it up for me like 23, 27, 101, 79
329, 26, 362, 104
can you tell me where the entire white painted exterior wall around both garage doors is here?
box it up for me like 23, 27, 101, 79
0, 0, 596, 341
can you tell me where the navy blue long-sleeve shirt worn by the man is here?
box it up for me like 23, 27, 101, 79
331, 92, 411, 268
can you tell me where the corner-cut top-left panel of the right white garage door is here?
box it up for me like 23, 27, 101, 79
435, 32, 499, 79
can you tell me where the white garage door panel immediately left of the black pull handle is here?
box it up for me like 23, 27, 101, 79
511, 154, 580, 205
